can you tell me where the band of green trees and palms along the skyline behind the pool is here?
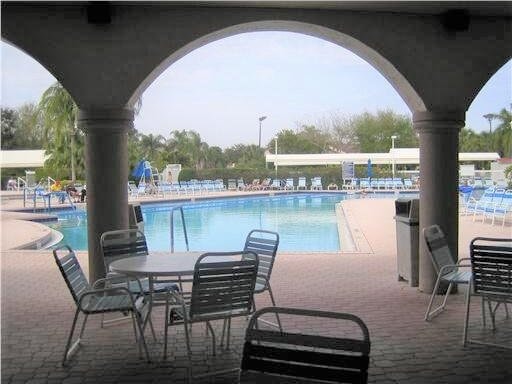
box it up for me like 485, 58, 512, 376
1, 83, 512, 184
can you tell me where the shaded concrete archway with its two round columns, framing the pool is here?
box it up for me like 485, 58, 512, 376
1, 2, 512, 284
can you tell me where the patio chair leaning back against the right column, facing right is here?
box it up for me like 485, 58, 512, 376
423, 224, 471, 321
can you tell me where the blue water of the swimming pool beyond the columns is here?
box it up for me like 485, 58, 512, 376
50, 193, 416, 252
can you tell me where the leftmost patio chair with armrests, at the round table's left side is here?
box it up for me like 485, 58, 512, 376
53, 245, 150, 365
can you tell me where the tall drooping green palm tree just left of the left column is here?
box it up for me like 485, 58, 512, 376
39, 82, 84, 182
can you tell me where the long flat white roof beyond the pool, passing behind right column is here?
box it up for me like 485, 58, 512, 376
266, 148, 500, 166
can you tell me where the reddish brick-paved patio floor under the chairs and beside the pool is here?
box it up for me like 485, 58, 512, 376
1, 199, 512, 384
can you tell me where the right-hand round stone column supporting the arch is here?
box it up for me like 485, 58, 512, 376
413, 111, 465, 293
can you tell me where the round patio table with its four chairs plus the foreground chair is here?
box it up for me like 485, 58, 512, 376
53, 229, 370, 383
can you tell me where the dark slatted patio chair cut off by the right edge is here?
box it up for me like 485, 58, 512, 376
462, 237, 512, 349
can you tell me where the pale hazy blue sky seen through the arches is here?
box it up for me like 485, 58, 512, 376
0, 32, 512, 148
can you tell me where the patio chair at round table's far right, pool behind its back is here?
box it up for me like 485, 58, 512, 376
244, 229, 281, 329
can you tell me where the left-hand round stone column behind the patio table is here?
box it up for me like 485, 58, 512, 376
78, 109, 133, 282
